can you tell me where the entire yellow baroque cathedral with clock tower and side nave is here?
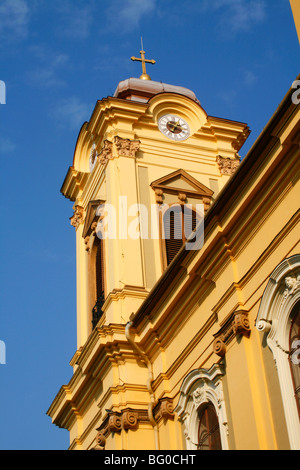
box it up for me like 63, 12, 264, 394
47, 4, 300, 451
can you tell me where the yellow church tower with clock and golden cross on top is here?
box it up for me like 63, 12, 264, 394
48, 50, 249, 450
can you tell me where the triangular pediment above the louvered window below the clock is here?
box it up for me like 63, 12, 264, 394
151, 169, 213, 198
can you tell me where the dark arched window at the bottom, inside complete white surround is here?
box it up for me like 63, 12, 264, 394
198, 403, 222, 450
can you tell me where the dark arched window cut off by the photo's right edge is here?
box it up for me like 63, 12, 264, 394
290, 307, 300, 417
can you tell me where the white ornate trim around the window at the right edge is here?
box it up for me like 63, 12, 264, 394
256, 255, 300, 450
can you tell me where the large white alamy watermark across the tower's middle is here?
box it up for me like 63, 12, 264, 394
95, 196, 204, 250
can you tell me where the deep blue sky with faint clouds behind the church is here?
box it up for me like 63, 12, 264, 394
0, 0, 299, 450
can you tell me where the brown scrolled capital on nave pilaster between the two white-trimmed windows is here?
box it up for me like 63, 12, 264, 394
213, 310, 251, 357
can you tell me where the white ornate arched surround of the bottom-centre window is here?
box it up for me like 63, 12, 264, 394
174, 364, 228, 450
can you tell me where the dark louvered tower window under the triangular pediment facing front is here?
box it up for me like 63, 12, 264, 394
163, 204, 197, 265
